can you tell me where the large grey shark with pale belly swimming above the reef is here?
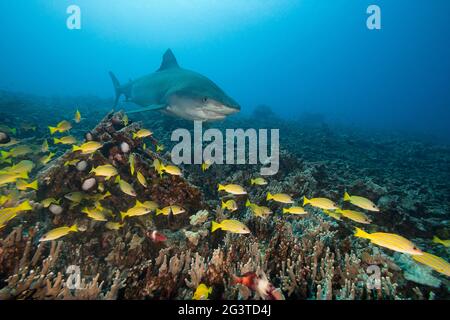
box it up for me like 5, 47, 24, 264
109, 49, 241, 121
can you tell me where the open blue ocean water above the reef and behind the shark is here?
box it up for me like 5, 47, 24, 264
0, 0, 450, 141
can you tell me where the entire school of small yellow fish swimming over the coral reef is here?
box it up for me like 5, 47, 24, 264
0, 110, 450, 299
